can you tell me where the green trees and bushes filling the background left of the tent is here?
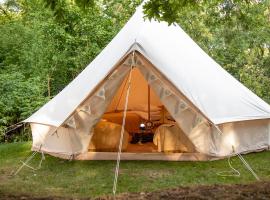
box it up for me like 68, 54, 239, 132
0, 0, 138, 142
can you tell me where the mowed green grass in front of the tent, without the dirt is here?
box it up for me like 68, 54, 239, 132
0, 142, 270, 198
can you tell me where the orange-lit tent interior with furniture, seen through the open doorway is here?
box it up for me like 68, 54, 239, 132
84, 54, 196, 158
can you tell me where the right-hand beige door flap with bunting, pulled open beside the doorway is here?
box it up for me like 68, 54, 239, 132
138, 55, 217, 155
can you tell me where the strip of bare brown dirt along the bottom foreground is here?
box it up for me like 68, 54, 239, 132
0, 182, 270, 200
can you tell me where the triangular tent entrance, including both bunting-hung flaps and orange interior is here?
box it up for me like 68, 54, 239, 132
49, 52, 216, 160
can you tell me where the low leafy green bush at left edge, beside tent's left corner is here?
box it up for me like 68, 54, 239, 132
0, 72, 47, 142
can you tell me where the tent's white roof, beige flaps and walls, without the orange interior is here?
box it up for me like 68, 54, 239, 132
24, 3, 270, 160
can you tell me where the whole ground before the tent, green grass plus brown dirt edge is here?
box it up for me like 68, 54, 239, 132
0, 142, 270, 199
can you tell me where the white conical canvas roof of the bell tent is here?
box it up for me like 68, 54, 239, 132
24, 6, 270, 127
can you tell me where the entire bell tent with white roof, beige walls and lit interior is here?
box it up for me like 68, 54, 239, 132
24, 3, 270, 160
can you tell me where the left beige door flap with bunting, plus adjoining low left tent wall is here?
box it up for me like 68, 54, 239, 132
31, 55, 131, 155
